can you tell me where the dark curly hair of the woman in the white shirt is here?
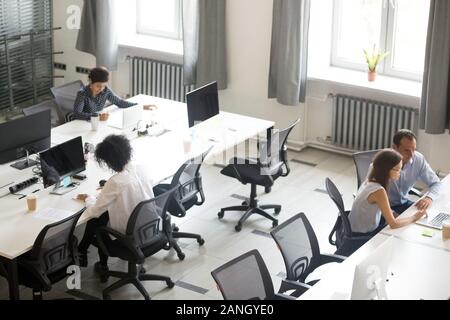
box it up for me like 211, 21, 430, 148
95, 134, 133, 172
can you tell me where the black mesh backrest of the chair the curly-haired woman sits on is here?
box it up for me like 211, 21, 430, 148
126, 188, 176, 248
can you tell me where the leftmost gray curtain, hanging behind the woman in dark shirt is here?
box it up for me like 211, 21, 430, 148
76, 0, 118, 70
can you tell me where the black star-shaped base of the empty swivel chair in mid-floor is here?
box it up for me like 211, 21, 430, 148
217, 184, 281, 232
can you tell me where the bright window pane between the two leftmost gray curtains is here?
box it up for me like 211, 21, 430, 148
136, 0, 182, 40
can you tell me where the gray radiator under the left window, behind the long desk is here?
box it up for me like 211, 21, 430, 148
130, 57, 194, 102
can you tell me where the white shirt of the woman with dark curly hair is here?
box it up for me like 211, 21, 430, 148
85, 163, 153, 234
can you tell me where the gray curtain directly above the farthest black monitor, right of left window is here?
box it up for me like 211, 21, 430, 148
183, 0, 227, 89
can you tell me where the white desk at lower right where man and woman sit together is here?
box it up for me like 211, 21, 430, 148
299, 175, 450, 300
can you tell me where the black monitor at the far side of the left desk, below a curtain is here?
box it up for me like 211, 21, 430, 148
186, 82, 219, 127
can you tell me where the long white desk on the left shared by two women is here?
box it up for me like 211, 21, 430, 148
0, 95, 274, 299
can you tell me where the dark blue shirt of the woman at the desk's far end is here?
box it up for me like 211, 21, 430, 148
73, 85, 136, 120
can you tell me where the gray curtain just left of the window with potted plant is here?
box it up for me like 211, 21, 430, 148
269, 0, 310, 105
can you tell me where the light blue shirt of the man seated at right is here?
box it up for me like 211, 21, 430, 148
389, 151, 442, 207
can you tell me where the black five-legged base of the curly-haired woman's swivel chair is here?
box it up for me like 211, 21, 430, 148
103, 262, 175, 300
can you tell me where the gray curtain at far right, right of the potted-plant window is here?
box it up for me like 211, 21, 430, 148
420, 0, 450, 134
